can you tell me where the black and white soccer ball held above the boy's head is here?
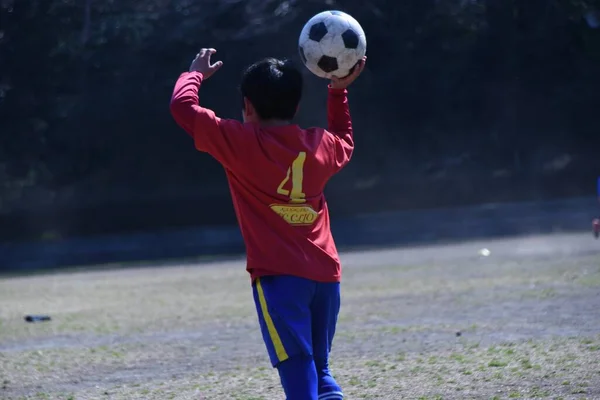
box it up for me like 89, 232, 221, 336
298, 11, 367, 79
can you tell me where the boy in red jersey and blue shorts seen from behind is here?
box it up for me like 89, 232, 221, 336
171, 49, 366, 400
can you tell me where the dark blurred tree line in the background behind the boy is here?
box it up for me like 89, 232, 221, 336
0, 0, 600, 239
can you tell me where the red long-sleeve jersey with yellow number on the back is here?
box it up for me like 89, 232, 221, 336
171, 72, 354, 282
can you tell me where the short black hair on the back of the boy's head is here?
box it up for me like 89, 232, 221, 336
240, 58, 303, 121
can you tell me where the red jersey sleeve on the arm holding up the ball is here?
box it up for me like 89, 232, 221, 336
327, 87, 354, 172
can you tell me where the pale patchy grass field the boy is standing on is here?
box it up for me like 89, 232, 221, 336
0, 234, 600, 400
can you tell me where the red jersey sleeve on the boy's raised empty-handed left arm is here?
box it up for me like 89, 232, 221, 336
171, 72, 247, 168
